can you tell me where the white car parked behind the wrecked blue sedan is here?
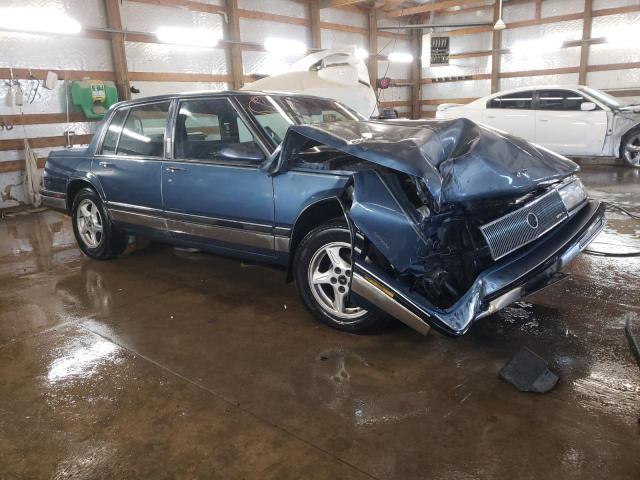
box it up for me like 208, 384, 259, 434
436, 85, 640, 167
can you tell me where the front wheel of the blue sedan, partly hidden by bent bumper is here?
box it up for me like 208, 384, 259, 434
293, 222, 389, 333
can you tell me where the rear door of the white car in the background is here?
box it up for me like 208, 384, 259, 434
482, 90, 535, 142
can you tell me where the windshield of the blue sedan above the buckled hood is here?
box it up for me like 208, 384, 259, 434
236, 95, 364, 145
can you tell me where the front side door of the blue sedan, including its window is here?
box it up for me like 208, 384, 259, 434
162, 96, 274, 256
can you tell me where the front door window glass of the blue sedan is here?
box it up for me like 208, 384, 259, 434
175, 98, 260, 161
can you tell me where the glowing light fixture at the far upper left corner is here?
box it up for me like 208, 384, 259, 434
0, 7, 82, 33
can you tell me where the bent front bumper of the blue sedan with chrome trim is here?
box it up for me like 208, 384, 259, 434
351, 200, 605, 336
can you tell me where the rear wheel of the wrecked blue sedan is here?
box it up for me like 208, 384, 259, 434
71, 188, 127, 260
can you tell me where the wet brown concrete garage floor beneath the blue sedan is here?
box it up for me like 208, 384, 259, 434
0, 166, 640, 480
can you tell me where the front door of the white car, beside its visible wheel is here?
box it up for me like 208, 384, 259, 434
535, 89, 607, 155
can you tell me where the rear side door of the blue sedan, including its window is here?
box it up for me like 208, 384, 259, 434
91, 101, 171, 231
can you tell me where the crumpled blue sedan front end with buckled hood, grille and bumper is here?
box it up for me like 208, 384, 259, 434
274, 119, 604, 336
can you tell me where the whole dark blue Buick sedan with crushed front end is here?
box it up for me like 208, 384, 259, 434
41, 91, 604, 336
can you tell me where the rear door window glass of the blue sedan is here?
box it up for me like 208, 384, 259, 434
116, 102, 171, 157
